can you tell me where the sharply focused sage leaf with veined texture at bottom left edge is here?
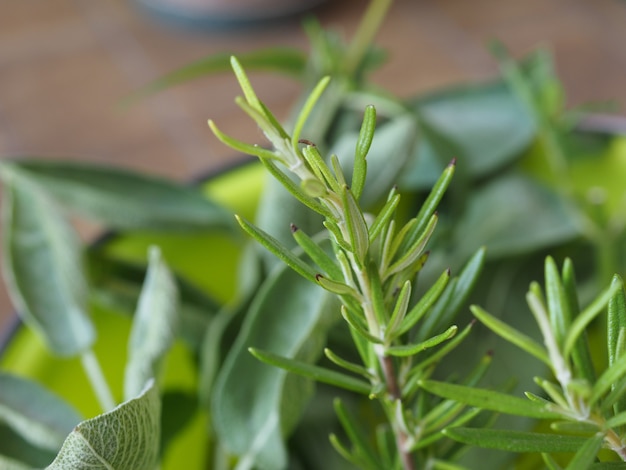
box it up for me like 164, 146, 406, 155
47, 380, 161, 470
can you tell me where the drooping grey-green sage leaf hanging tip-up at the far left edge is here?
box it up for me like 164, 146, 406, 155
3, 178, 96, 356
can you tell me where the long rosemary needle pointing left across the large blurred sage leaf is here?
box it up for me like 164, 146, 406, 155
248, 348, 372, 395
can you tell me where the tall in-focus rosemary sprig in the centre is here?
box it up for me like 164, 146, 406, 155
209, 58, 482, 469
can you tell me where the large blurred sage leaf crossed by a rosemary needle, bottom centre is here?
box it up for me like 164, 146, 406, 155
211, 262, 339, 469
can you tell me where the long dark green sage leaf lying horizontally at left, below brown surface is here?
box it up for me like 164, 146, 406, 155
0, 160, 235, 231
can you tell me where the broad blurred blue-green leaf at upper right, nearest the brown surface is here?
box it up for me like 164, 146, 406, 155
401, 81, 535, 189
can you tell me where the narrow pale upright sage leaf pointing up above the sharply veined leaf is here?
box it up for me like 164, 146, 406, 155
124, 247, 179, 400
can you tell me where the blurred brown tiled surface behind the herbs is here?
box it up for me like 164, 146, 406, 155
0, 0, 626, 331
